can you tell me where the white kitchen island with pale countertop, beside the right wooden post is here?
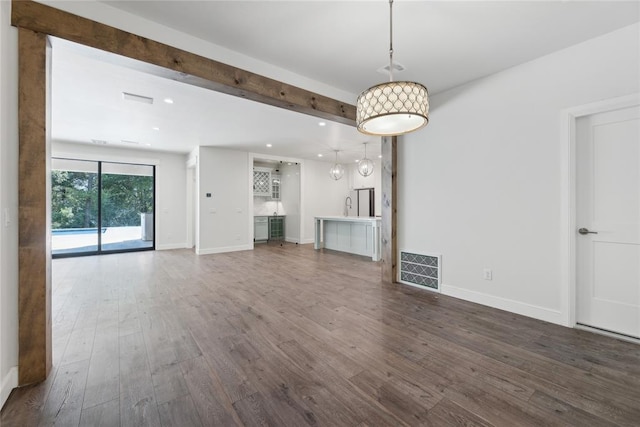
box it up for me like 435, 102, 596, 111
313, 216, 382, 261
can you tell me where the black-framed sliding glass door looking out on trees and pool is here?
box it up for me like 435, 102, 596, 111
51, 158, 155, 257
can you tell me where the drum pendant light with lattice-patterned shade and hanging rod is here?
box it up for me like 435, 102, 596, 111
356, 0, 429, 136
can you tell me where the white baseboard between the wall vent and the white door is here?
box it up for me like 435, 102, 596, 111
441, 283, 566, 326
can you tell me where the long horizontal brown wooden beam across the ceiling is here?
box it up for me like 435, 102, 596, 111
11, 0, 356, 126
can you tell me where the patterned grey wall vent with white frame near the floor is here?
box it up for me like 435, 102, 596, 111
398, 251, 442, 292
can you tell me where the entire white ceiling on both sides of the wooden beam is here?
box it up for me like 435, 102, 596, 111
53, 0, 640, 161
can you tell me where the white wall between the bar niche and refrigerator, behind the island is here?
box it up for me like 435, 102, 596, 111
301, 160, 349, 243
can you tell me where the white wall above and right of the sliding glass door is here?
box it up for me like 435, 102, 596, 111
51, 141, 187, 249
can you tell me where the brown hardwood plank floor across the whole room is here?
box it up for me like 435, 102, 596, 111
0, 244, 640, 427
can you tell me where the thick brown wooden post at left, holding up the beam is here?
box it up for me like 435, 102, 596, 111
18, 28, 52, 385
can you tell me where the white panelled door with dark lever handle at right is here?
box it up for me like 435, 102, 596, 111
576, 106, 640, 337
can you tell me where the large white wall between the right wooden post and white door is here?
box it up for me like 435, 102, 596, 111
398, 24, 640, 323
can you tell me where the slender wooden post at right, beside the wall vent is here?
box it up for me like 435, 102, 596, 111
381, 136, 398, 283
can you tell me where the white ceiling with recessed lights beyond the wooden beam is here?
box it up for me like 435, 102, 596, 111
52, 39, 380, 162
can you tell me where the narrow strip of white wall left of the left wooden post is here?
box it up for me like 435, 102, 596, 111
0, 1, 18, 407
